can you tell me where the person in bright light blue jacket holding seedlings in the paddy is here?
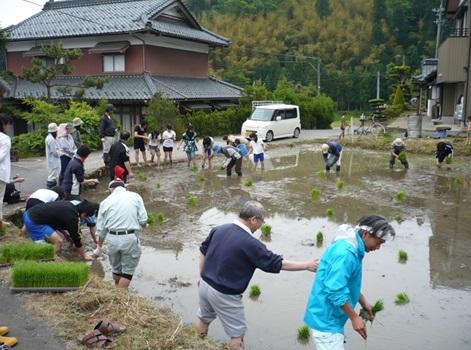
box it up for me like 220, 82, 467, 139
304, 215, 395, 350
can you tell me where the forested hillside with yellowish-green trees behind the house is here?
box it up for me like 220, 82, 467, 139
185, 0, 440, 109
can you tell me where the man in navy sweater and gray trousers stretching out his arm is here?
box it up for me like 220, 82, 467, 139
196, 201, 318, 350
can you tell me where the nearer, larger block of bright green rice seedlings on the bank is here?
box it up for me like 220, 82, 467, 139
11, 261, 88, 288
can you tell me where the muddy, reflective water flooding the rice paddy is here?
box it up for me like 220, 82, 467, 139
86, 147, 471, 350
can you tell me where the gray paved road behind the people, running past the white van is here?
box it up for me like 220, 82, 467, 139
11, 129, 339, 194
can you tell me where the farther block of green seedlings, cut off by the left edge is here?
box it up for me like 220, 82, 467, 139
0, 243, 54, 263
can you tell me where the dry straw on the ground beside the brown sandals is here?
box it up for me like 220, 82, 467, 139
25, 278, 220, 350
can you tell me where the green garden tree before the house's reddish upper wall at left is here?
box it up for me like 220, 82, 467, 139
21, 43, 107, 100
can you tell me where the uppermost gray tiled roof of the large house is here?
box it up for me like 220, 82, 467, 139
7, 0, 228, 46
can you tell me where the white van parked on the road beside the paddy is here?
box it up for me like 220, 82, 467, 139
241, 103, 301, 142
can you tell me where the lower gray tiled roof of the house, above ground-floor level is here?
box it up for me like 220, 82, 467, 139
9, 74, 242, 102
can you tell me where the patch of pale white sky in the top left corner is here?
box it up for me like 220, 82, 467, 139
0, 0, 47, 28
